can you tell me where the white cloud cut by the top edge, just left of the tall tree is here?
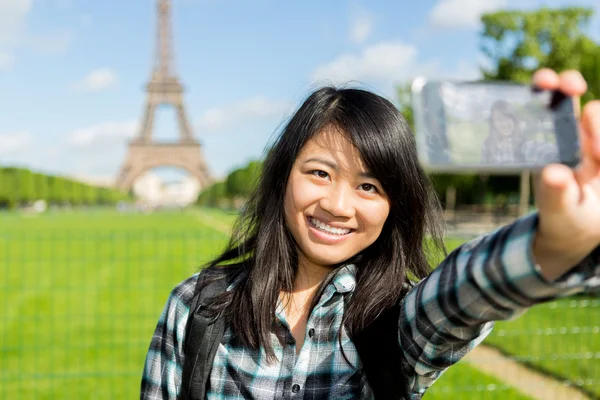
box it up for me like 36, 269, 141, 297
429, 0, 508, 29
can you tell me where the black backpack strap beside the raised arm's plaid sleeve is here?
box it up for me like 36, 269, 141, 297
352, 305, 414, 400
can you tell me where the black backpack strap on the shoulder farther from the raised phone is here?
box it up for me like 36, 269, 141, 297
179, 268, 228, 400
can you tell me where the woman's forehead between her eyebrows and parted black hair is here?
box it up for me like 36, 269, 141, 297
298, 126, 366, 170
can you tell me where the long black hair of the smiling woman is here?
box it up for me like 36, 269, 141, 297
204, 87, 445, 359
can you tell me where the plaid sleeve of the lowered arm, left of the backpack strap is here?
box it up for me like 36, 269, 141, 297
140, 274, 198, 400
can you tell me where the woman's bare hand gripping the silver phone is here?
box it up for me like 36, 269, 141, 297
533, 69, 600, 281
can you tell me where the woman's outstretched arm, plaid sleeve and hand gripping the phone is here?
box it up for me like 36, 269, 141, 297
399, 69, 600, 393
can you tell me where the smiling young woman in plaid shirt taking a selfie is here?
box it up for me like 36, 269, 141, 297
141, 70, 600, 399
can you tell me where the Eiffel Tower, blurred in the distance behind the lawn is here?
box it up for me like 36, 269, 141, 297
116, 0, 211, 191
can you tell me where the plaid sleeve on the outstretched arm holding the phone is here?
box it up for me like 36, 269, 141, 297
399, 213, 600, 394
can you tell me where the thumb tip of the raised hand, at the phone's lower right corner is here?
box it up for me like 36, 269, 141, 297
537, 164, 579, 212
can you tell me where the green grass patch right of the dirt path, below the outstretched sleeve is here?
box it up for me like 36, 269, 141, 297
447, 240, 600, 398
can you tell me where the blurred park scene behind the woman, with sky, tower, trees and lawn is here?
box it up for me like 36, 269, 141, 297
0, 0, 600, 399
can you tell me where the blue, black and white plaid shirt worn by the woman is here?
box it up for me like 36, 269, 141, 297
141, 214, 600, 400
